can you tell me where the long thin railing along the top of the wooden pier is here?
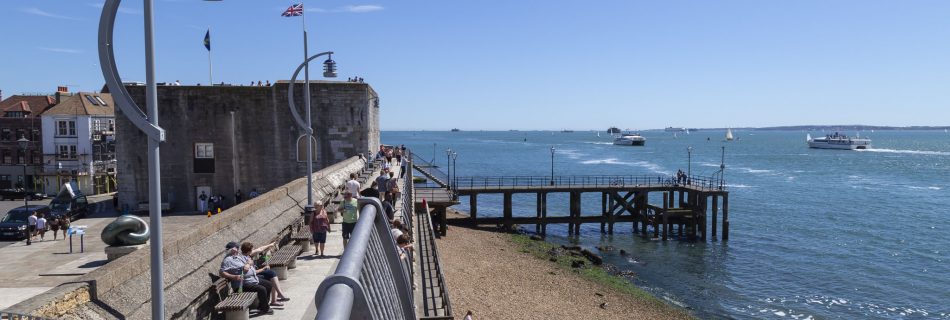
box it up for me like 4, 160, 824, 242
455, 175, 722, 190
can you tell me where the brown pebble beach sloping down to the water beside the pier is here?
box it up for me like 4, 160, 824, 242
438, 214, 691, 320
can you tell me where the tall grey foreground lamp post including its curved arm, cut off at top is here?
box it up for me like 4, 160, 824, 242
99, 0, 165, 319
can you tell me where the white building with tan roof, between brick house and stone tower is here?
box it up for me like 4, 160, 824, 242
40, 92, 116, 194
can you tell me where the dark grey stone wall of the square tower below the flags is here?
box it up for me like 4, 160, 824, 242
116, 82, 379, 211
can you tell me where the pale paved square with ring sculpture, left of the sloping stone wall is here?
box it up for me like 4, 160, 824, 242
0, 195, 207, 310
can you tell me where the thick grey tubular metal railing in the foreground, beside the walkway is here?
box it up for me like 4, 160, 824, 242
314, 198, 416, 320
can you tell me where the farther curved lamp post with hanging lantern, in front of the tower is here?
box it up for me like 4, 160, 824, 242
287, 51, 336, 221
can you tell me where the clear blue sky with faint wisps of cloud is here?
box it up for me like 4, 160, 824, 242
0, 0, 950, 130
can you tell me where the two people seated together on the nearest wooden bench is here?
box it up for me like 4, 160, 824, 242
218, 241, 290, 315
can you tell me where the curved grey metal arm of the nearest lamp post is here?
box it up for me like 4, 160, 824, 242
99, 0, 165, 142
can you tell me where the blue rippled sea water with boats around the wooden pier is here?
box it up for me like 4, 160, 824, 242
382, 131, 950, 319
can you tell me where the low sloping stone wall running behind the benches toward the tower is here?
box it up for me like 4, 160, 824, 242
10, 157, 365, 319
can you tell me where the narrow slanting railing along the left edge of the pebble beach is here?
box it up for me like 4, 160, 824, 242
416, 200, 452, 319
